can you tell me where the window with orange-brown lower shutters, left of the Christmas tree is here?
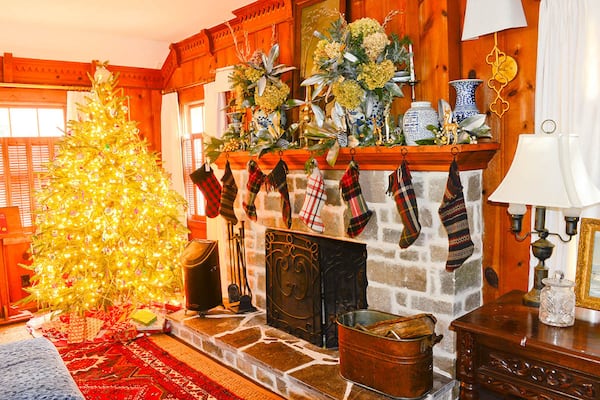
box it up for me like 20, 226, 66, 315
0, 106, 65, 228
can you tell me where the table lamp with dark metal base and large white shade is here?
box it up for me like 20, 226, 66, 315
489, 133, 600, 307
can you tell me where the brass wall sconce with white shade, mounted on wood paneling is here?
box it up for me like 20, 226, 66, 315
462, 0, 527, 117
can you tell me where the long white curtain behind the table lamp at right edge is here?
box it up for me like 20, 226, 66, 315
530, 0, 600, 279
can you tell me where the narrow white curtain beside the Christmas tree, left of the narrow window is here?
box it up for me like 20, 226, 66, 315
160, 92, 185, 203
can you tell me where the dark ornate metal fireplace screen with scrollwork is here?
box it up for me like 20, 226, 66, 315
265, 229, 367, 348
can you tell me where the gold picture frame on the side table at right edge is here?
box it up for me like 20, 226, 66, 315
575, 218, 600, 310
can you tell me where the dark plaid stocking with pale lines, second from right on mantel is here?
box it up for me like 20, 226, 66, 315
387, 161, 421, 249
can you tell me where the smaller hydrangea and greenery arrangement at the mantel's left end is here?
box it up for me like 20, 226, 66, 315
205, 44, 301, 160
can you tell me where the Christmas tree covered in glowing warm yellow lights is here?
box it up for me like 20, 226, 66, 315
26, 65, 187, 315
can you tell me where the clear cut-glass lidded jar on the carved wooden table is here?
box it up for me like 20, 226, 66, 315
539, 274, 575, 327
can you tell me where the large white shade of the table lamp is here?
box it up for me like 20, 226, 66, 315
489, 133, 600, 209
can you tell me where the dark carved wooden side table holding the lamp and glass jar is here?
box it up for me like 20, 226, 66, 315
451, 291, 600, 400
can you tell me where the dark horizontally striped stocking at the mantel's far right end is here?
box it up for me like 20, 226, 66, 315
438, 161, 474, 272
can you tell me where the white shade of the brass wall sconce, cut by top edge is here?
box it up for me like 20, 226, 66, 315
462, 0, 527, 40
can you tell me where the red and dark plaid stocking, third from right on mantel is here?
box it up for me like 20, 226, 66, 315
340, 162, 373, 237
